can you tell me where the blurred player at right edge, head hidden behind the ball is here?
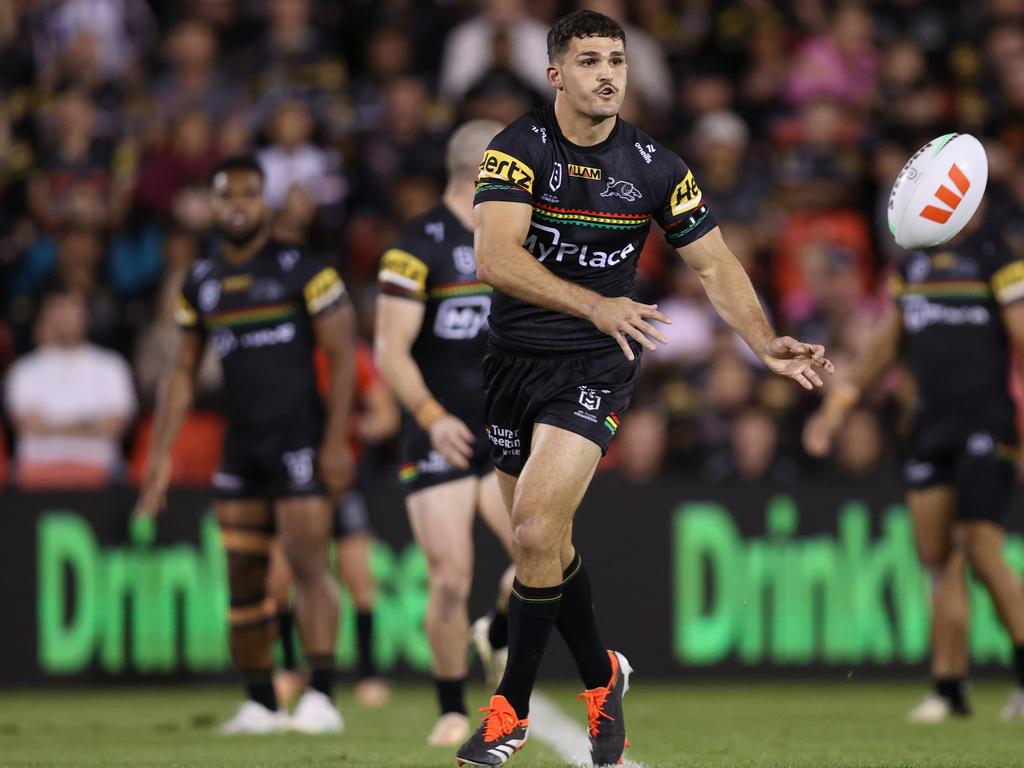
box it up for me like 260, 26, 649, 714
804, 204, 1024, 722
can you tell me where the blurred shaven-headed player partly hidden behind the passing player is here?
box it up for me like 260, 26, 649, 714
376, 121, 512, 746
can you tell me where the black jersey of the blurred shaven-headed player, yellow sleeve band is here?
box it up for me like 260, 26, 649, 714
378, 198, 492, 414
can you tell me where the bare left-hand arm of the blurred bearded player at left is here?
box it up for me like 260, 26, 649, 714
135, 295, 206, 517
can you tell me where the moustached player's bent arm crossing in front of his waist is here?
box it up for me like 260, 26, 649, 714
473, 200, 672, 360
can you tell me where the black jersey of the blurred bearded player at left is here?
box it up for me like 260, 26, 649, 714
175, 241, 345, 426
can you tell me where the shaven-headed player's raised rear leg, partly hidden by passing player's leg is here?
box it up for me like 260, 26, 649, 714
471, 472, 515, 690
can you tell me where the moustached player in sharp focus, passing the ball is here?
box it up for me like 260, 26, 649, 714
457, 11, 831, 765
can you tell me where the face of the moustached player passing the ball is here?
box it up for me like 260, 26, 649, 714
549, 37, 627, 120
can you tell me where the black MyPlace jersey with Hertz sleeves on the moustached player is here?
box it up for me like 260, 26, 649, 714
475, 105, 715, 353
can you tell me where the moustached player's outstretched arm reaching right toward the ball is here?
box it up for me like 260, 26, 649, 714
677, 226, 835, 389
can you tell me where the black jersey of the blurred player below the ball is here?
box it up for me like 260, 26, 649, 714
891, 214, 1024, 421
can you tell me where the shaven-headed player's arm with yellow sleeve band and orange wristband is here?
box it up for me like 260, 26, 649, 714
374, 248, 474, 469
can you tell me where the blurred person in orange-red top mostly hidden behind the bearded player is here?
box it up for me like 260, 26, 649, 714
269, 342, 399, 707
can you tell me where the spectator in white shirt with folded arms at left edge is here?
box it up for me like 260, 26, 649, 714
6, 292, 135, 487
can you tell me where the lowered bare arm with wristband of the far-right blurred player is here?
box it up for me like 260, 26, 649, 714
804, 303, 903, 457
